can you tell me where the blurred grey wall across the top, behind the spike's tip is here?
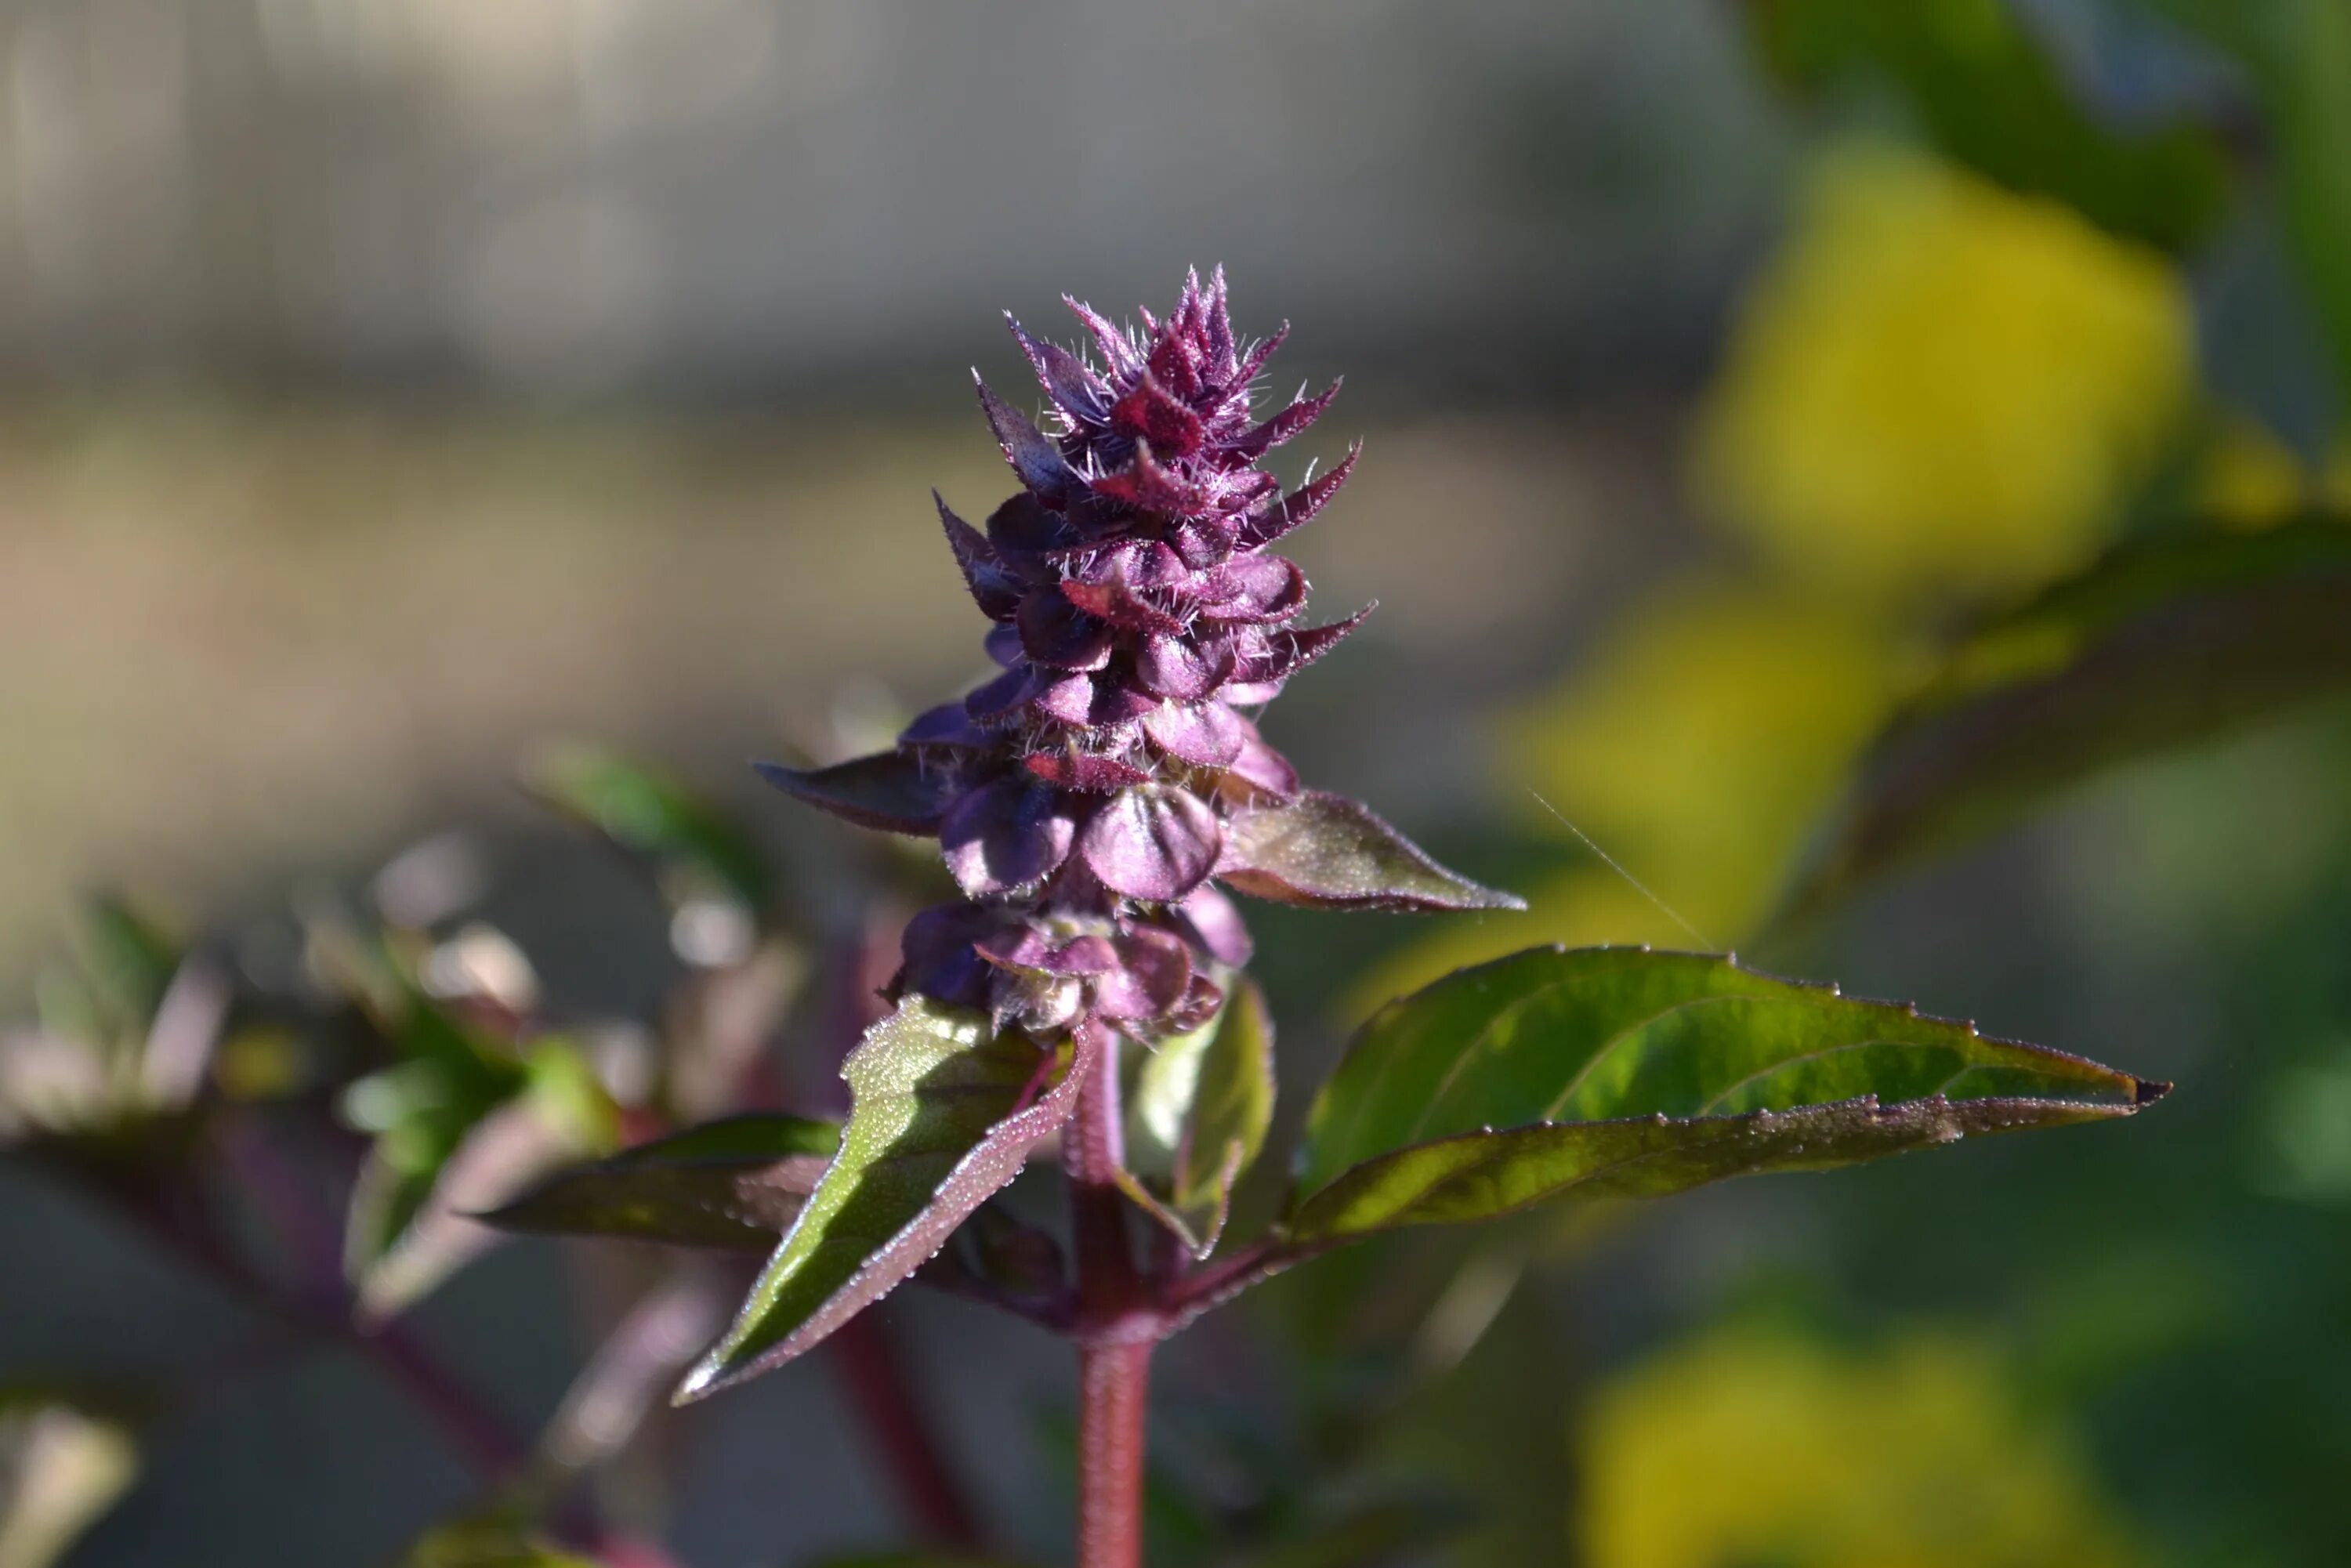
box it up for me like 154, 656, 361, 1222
0, 0, 1782, 393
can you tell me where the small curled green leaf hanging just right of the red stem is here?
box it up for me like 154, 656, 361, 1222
1119, 980, 1274, 1258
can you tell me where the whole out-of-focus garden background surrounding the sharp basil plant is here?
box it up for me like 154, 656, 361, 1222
0, 0, 2351, 1568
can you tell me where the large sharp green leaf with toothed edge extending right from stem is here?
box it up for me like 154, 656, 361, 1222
1288, 947, 2170, 1246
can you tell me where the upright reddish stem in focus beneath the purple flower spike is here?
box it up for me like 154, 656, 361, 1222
1065, 1041, 1161, 1568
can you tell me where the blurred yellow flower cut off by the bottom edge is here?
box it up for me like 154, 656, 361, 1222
1578, 1328, 2139, 1568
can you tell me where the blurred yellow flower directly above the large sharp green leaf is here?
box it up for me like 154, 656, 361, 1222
1352, 583, 1907, 1011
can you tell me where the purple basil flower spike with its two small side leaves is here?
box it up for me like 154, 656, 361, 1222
762, 268, 1519, 1039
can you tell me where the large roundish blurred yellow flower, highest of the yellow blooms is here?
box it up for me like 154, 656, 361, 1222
1697, 148, 2196, 595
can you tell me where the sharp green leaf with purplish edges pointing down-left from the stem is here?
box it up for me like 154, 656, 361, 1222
677, 997, 1100, 1401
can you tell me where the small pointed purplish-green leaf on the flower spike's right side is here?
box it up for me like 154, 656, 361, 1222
1215, 792, 1526, 910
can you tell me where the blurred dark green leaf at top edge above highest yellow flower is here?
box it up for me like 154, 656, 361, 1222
1747, 0, 2229, 252
